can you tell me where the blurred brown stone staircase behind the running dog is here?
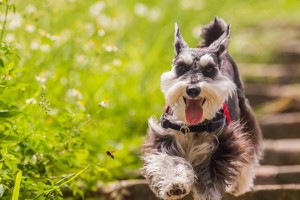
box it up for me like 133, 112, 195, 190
94, 38, 300, 200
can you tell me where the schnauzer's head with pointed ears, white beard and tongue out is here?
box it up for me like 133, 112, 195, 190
161, 24, 236, 125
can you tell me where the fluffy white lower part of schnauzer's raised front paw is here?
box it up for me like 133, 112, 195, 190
142, 152, 195, 199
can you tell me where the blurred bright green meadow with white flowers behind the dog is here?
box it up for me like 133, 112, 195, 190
0, 0, 300, 199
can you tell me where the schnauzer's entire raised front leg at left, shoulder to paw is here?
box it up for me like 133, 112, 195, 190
142, 118, 195, 199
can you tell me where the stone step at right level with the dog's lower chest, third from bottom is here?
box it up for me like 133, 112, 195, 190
260, 139, 300, 166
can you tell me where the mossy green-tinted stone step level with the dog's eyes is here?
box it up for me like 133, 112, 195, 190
239, 63, 300, 84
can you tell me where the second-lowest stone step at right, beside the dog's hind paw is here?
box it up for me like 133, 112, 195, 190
255, 165, 300, 185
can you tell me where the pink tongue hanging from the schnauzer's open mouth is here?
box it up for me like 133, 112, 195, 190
185, 99, 203, 125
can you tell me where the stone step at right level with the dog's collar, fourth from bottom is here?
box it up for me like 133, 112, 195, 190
258, 112, 300, 140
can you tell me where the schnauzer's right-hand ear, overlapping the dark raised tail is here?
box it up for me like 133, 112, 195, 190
208, 24, 230, 56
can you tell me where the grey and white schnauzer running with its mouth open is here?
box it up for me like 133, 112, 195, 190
142, 17, 262, 200
